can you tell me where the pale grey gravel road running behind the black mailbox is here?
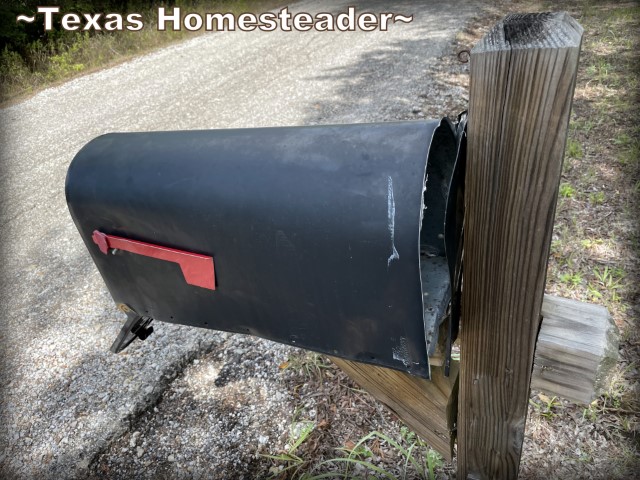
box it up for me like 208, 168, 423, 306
0, 0, 477, 478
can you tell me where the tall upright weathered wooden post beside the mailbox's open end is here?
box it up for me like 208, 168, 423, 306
457, 13, 582, 479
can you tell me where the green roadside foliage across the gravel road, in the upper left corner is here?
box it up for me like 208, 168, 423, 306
0, 0, 264, 102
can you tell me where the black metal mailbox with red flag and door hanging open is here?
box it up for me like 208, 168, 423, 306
66, 120, 458, 378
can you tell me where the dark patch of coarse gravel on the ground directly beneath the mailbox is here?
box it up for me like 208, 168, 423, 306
86, 335, 291, 479
